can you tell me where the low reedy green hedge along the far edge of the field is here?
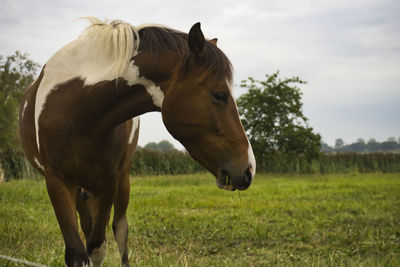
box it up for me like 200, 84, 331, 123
0, 149, 400, 180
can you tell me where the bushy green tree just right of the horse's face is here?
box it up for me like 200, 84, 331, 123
237, 71, 321, 171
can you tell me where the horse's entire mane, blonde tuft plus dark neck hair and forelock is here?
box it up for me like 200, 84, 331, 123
82, 17, 232, 83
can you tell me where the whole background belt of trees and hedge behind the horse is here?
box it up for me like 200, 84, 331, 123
0, 51, 400, 179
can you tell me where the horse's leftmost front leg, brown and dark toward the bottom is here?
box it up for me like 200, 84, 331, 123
45, 171, 90, 267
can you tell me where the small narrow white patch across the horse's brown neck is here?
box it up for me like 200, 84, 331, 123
123, 60, 164, 108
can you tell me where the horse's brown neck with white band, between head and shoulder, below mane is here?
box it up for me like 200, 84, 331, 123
90, 52, 177, 132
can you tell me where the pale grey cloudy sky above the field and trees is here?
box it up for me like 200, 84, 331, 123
0, 0, 400, 148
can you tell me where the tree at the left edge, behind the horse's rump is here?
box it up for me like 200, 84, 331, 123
0, 51, 39, 152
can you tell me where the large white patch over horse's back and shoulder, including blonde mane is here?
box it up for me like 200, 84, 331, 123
35, 18, 139, 152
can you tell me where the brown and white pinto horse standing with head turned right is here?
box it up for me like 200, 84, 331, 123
19, 17, 256, 266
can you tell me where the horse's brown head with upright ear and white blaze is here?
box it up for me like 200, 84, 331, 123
162, 23, 256, 190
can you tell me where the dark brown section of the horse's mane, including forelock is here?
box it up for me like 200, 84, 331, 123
136, 25, 233, 83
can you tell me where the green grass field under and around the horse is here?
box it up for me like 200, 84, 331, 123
0, 174, 400, 266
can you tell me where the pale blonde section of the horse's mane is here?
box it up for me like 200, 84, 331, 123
81, 17, 139, 76
